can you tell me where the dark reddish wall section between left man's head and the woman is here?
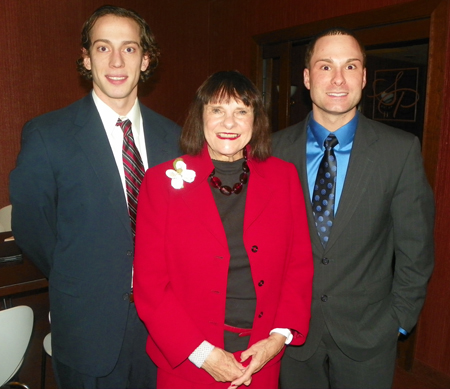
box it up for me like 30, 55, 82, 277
140, 0, 210, 124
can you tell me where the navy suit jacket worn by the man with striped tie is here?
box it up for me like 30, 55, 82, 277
10, 94, 179, 376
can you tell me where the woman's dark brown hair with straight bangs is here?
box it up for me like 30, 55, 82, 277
180, 71, 271, 161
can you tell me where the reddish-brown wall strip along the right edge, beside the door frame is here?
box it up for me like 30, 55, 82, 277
416, 2, 450, 372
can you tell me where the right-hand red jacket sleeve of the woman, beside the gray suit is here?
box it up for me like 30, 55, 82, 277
276, 164, 314, 346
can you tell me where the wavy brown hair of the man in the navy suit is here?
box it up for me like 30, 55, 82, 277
77, 5, 160, 81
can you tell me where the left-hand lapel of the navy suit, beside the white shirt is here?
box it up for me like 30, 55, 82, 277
75, 94, 131, 235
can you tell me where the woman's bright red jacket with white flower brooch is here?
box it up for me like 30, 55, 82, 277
134, 148, 313, 383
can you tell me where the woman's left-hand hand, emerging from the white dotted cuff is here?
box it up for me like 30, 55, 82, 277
202, 347, 252, 385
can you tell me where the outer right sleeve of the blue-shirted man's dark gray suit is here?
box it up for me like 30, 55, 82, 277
391, 138, 434, 332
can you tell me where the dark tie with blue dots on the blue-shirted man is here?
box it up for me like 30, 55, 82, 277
312, 134, 339, 247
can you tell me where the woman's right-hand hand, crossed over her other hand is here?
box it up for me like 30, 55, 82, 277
230, 333, 286, 388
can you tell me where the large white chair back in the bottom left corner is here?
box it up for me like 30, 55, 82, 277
0, 305, 33, 386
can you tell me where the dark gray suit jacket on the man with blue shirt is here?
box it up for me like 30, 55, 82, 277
274, 115, 434, 360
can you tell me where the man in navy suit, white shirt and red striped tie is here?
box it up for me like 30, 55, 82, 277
10, 6, 180, 389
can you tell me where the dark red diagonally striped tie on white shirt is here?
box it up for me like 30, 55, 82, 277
116, 119, 145, 237
